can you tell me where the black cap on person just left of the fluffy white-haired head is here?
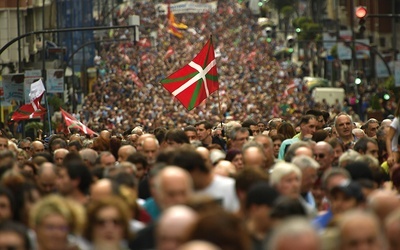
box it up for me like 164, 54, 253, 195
246, 182, 279, 207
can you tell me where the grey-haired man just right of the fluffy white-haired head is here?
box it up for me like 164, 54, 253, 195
292, 155, 319, 208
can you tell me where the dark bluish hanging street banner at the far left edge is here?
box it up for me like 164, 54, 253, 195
3, 74, 24, 105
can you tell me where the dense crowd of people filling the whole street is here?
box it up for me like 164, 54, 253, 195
0, 1, 400, 250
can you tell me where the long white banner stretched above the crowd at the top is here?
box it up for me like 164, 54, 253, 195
155, 1, 218, 16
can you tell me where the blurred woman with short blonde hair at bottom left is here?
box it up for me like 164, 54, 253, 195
30, 195, 86, 250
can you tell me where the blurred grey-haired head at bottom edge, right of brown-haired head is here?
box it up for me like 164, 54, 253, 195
268, 218, 322, 250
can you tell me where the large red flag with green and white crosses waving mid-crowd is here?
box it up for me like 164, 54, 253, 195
161, 38, 219, 110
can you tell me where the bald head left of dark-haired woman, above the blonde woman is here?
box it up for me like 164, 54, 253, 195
36, 162, 57, 196
